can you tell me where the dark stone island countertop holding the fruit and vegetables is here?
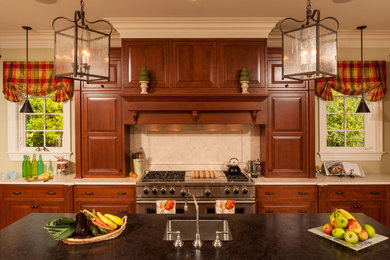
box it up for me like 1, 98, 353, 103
0, 213, 390, 260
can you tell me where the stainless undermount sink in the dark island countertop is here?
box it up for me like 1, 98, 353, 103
164, 218, 232, 241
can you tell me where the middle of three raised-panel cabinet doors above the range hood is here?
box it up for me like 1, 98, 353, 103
172, 41, 217, 88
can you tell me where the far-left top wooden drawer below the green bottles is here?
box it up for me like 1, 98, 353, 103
4, 185, 64, 198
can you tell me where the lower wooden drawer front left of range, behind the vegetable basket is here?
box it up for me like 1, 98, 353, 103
76, 201, 135, 214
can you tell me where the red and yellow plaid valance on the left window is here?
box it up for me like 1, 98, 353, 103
3, 61, 73, 102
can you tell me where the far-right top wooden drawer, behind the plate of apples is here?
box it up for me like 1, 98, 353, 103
328, 185, 387, 199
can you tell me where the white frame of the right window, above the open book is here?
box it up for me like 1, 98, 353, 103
318, 98, 384, 161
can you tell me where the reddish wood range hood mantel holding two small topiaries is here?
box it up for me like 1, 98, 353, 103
121, 93, 268, 125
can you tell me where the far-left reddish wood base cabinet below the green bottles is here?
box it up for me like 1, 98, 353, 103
0, 185, 73, 227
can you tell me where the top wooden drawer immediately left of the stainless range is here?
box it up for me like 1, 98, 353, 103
75, 185, 135, 200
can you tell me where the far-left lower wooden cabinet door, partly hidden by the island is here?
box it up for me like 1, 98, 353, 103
4, 201, 38, 226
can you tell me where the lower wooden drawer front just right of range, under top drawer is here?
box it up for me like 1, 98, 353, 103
257, 202, 314, 214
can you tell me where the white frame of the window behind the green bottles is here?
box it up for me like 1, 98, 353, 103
7, 101, 72, 161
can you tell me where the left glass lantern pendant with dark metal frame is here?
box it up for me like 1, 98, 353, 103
52, 0, 112, 82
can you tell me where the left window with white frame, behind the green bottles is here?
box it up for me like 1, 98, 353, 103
8, 96, 71, 161
